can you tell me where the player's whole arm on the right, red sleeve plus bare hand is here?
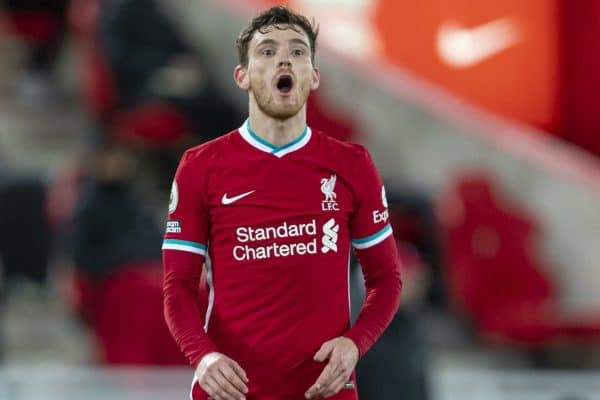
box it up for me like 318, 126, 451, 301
305, 147, 402, 398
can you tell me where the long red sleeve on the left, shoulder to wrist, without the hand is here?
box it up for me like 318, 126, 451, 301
162, 151, 216, 366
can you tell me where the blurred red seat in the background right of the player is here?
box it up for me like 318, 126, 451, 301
437, 171, 600, 346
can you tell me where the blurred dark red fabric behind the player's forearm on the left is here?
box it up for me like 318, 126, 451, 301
75, 263, 186, 365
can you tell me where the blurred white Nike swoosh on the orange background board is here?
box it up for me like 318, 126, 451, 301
436, 17, 521, 68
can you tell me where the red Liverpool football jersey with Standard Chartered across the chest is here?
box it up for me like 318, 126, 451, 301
163, 121, 400, 400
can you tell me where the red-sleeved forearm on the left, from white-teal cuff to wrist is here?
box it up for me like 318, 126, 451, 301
163, 250, 217, 367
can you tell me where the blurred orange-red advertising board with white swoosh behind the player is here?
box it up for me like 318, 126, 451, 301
263, 0, 565, 133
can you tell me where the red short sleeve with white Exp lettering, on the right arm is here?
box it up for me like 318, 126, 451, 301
350, 147, 392, 249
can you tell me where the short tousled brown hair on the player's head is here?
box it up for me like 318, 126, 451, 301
235, 6, 319, 67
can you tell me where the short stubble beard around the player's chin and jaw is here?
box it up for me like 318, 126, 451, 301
250, 74, 310, 121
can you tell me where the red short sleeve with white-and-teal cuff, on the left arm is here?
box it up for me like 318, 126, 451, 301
162, 153, 208, 256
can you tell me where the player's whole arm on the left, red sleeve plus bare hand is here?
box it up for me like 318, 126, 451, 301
162, 152, 248, 399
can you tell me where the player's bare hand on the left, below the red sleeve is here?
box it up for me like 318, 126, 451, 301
196, 352, 248, 400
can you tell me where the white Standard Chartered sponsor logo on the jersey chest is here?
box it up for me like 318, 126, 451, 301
233, 218, 340, 261
